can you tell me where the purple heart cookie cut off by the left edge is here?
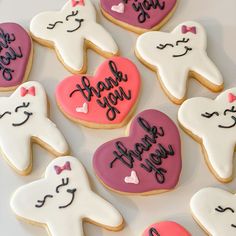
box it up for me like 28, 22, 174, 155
0, 23, 33, 91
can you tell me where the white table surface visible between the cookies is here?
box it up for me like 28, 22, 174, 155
0, 0, 236, 236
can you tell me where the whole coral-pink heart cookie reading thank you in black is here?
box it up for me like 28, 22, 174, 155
56, 57, 141, 128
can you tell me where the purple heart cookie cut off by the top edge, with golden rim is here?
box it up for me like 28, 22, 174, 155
100, 0, 177, 33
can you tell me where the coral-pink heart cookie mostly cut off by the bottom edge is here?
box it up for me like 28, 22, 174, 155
142, 221, 191, 236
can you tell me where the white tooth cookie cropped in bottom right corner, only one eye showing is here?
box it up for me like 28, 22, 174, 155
190, 188, 236, 236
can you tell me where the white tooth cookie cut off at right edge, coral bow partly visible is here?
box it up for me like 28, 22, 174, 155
178, 88, 236, 181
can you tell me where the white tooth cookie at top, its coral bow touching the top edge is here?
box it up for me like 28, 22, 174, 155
30, 0, 118, 73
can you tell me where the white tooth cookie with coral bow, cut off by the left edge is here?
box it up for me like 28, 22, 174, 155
0, 82, 68, 175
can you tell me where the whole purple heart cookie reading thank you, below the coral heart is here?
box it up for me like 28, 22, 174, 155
93, 110, 182, 195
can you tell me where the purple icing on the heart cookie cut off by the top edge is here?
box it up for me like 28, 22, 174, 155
100, 0, 177, 29
